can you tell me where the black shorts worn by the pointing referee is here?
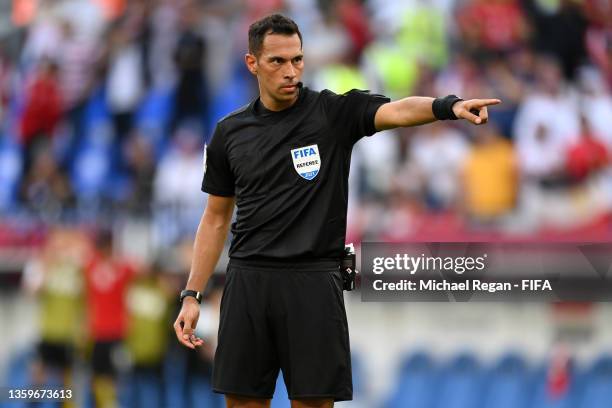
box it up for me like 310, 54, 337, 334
213, 259, 353, 401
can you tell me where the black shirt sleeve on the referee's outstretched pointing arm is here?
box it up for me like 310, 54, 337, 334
321, 89, 391, 146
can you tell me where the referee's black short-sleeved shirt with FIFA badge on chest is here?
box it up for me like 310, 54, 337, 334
202, 88, 389, 261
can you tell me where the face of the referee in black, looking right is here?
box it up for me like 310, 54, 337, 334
245, 34, 304, 110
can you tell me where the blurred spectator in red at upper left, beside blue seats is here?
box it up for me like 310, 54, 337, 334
21, 60, 63, 174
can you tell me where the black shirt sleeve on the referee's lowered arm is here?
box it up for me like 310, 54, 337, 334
202, 124, 235, 197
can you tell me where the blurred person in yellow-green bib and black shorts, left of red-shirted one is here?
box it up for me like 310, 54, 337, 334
23, 227, 87, 388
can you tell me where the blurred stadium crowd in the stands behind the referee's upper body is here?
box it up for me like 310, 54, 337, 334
0, 0, 612, 245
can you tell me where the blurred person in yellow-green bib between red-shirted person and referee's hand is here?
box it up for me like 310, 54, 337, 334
125, 263, 175, 408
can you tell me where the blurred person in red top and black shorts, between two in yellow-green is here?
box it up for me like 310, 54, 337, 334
85, 230, 134, 408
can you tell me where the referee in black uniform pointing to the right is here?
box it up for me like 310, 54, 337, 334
174, 15, 500, 407
